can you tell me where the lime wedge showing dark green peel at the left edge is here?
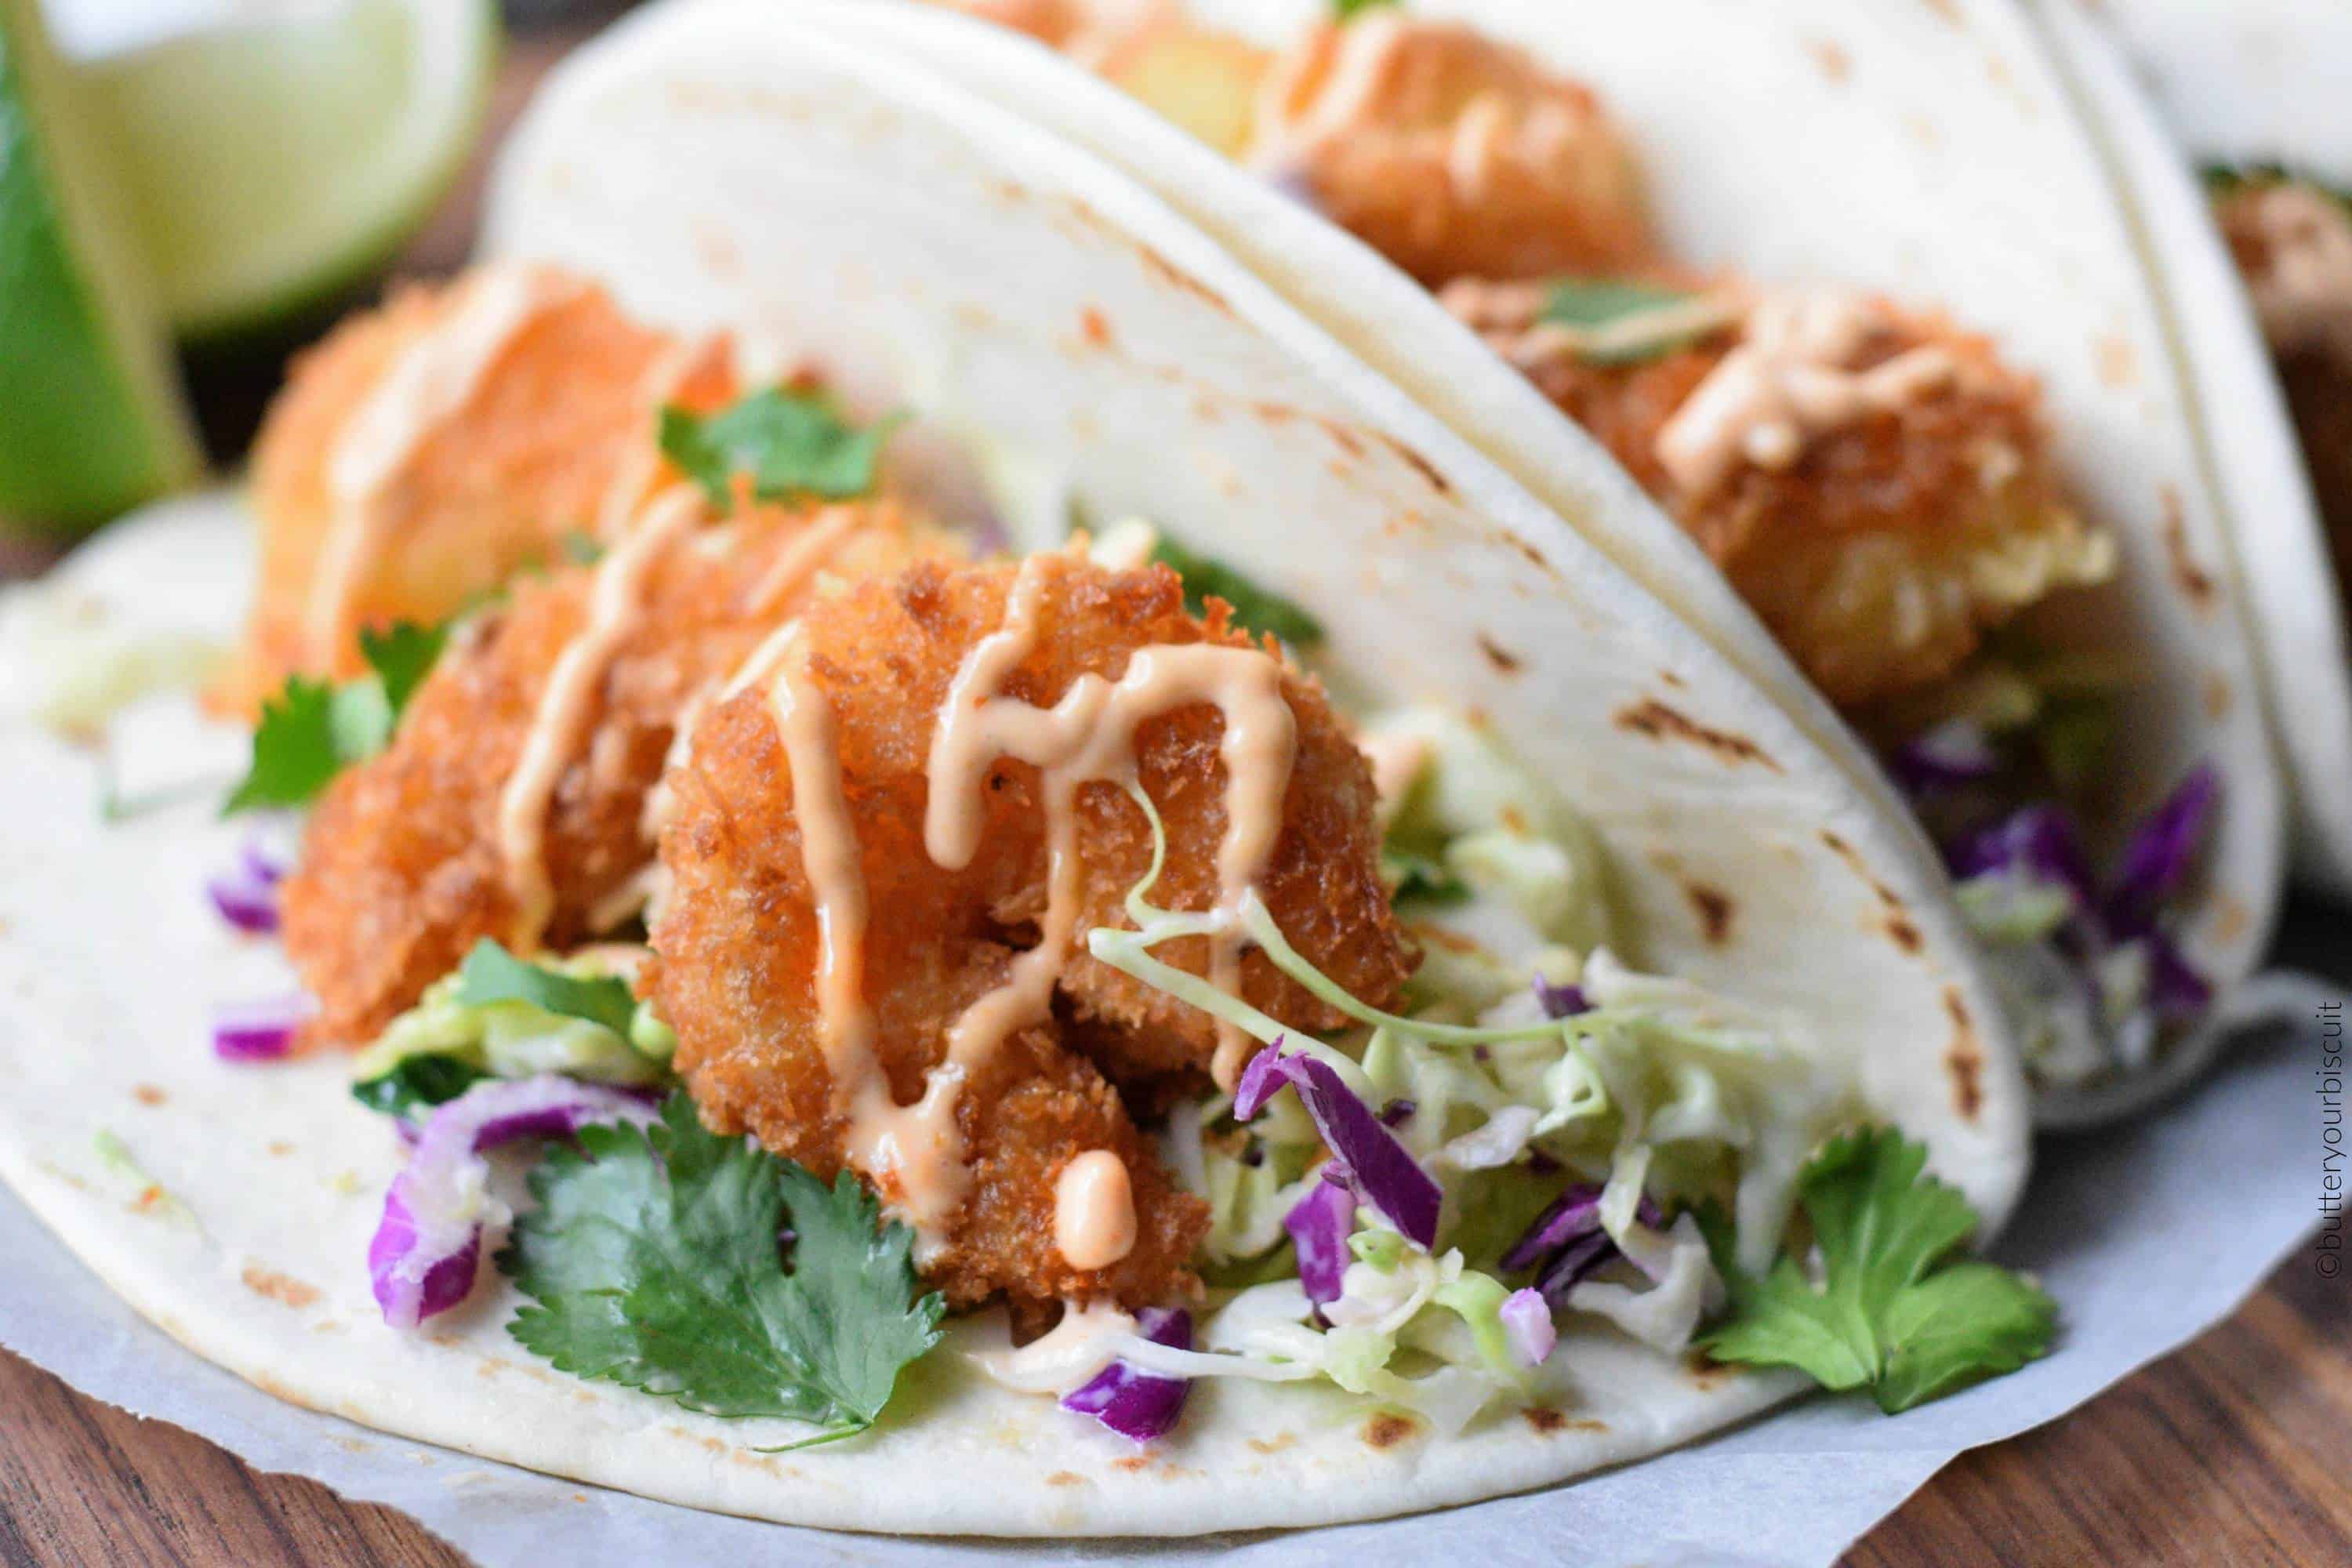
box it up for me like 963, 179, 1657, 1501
0, 0, 202, 532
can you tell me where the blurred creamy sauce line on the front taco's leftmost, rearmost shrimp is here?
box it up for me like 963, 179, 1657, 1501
303, 266, 586, 670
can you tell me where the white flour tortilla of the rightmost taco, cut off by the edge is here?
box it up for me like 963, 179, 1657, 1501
2037, 0, 2352, 898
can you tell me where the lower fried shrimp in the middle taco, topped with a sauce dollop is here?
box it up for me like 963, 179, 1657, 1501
1444, 280, 2114, 710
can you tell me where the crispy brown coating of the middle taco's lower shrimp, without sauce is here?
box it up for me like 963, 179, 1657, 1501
1444, 280, 2114, 713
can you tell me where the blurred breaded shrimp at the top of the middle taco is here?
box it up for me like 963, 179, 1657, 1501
1249, 9, 1653, 287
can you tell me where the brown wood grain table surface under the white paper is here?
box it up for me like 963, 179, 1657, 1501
0, 7, 2352, 1568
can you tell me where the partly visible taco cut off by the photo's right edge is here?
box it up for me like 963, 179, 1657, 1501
2044, 2, 2352, 895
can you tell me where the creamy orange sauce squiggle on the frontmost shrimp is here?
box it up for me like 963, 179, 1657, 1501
769, 557, 1296, 1267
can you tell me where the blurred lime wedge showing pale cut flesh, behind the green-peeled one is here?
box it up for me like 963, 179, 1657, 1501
85, 0, 499, 339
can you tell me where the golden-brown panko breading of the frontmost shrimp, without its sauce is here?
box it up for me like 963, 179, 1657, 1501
649, 555, 1409, 1305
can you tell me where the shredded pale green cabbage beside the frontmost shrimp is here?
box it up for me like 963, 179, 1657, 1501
1087, 713, 1853, 1429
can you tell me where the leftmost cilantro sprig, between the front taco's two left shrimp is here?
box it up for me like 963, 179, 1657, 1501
221, 621, 449, 815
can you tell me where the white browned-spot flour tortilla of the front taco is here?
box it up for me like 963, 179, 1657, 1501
0, 5, 2027, 1535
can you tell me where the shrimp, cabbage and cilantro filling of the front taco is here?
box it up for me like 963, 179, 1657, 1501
223, 273, 2060, 1443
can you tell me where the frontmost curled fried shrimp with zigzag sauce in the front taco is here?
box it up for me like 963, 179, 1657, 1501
652, 553, 1409, 1305
